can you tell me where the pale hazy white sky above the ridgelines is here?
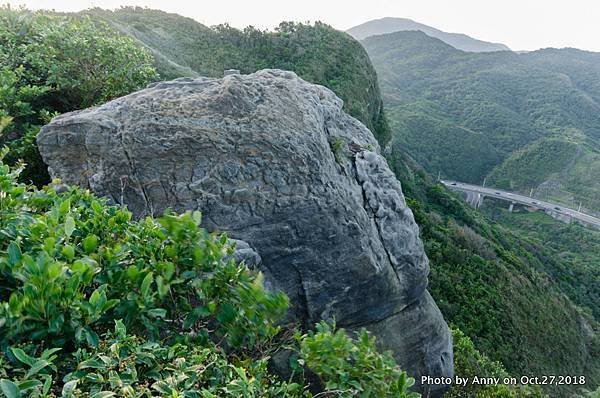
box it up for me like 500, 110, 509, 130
9, 0, 600, 51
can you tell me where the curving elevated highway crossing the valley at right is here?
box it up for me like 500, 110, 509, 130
440, 180, 600, 228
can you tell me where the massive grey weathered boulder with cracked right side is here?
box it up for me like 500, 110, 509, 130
38, 70, 453, 394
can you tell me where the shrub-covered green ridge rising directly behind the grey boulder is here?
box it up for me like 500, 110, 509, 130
84, 7, 387, 141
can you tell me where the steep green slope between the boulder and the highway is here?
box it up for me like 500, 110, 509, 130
388, 145, 600, 396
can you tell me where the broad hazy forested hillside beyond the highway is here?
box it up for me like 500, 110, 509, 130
364, 32, 600, 212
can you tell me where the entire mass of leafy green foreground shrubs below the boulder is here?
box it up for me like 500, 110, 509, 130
0, 151, 418, 398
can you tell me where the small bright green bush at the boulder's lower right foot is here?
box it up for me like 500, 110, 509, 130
298, 322, 419, 398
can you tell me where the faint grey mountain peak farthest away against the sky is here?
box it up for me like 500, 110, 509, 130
347, 18, 510, 53
